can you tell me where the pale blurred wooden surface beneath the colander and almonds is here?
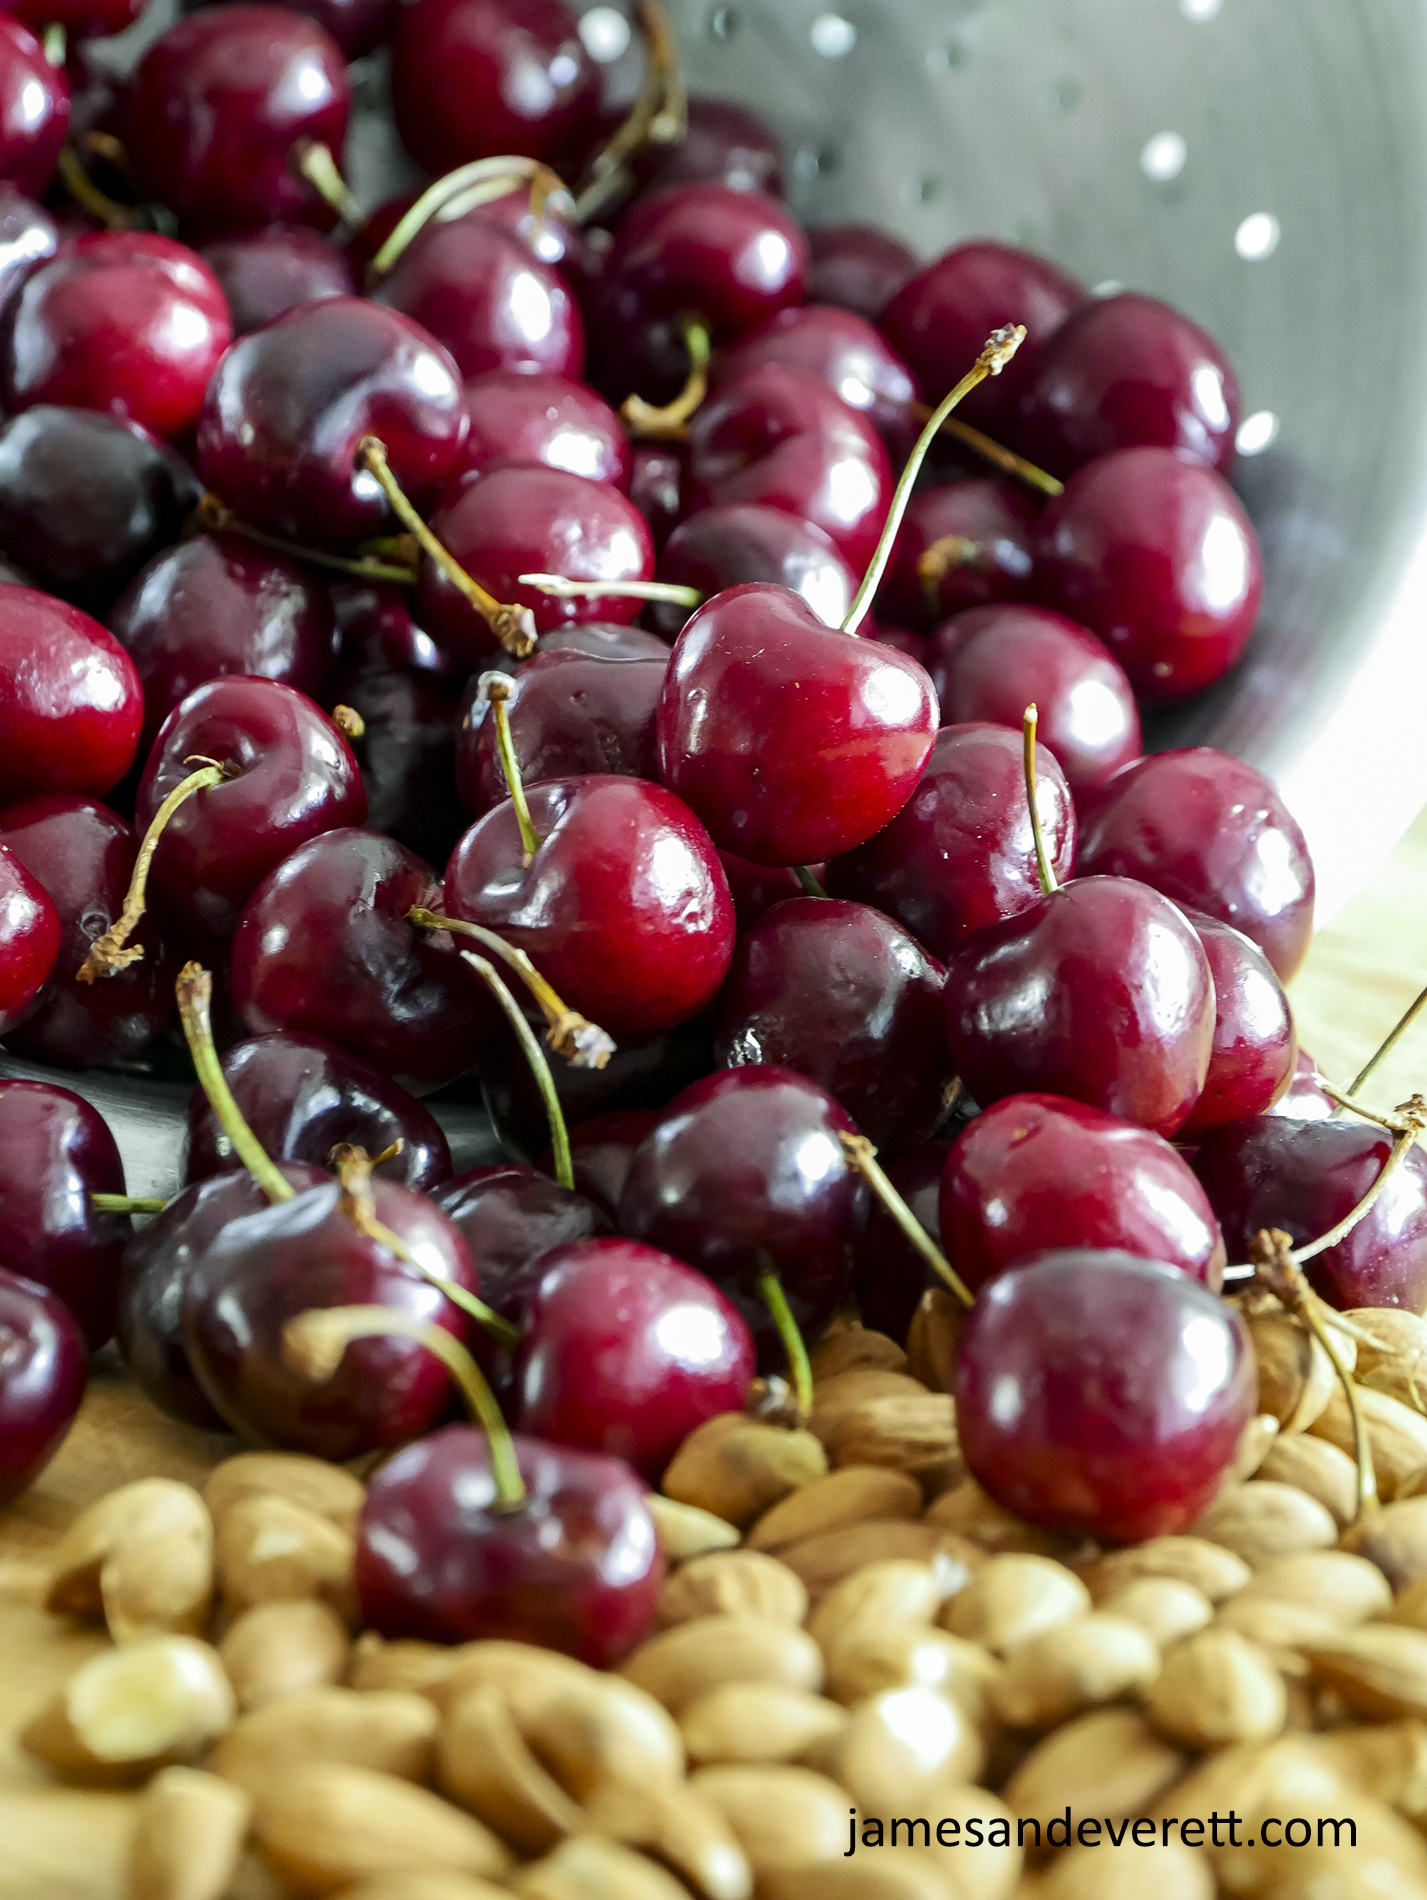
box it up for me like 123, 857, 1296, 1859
0, 815, 1427, 1900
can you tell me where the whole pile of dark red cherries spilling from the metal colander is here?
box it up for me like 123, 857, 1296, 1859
0, 0, 1406, 1661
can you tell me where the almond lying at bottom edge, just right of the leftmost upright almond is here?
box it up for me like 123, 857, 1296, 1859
253, 1761, 511, 1896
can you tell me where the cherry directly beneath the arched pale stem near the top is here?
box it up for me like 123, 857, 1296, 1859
374, 209, 585, 383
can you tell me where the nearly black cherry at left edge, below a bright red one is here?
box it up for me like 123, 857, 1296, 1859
0, 403, 201, 614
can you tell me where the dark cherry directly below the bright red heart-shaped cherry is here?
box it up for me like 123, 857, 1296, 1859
714, 897, 952, 1150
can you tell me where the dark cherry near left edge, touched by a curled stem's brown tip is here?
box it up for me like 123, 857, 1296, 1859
0, 792, 175, 1068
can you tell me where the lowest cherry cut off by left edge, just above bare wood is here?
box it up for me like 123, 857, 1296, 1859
0, 1267, 86, 1509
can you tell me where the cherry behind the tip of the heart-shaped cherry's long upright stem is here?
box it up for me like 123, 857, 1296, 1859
878, 238, 1085, 433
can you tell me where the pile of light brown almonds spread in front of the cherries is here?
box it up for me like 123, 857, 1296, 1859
23, 1292, 1427, 1900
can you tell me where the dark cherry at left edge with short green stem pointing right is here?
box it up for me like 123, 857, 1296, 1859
0, 1081, 129, 1347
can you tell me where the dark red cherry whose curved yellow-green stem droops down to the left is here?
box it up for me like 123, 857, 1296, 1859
135, 676, 367, 941
